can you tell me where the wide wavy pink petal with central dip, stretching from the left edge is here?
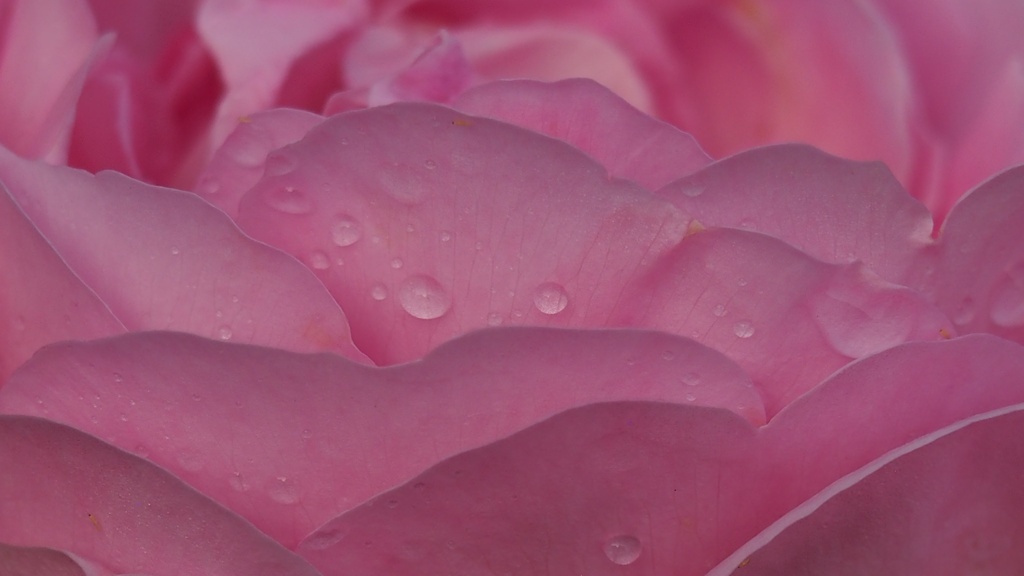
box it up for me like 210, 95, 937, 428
0, 329, 764, 547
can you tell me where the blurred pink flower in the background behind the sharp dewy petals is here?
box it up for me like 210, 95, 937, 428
0, 0, 1024, 222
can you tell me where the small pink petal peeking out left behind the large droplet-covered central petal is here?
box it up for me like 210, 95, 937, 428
196, 108, 324, 218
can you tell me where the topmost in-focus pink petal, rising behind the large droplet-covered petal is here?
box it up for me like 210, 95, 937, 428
455, 79, 711, 190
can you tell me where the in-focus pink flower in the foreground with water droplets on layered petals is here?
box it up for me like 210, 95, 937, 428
0, 69, 1024, 575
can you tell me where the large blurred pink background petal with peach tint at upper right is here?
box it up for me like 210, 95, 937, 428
665, 0, 915, 181
